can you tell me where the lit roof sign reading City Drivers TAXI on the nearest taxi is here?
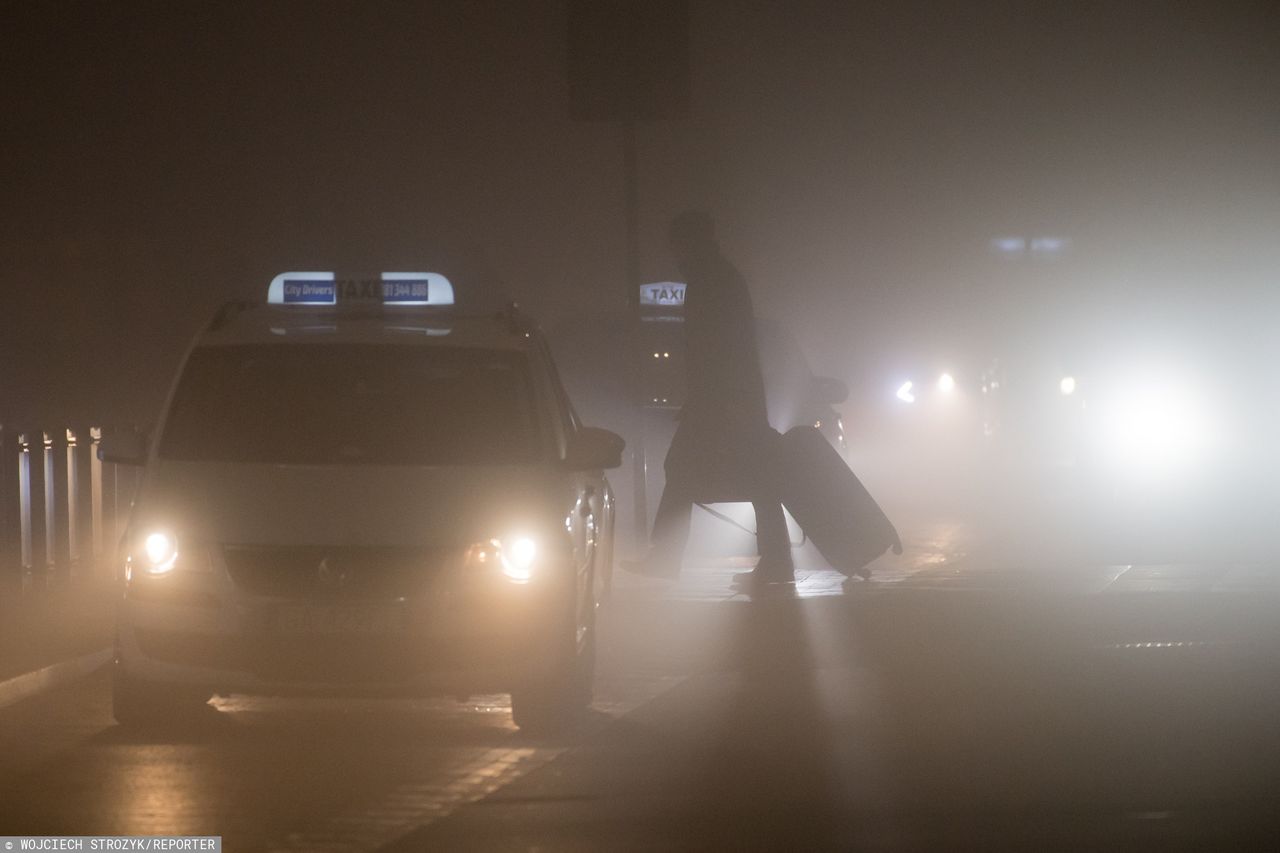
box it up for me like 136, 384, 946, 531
266, 273, 453, 307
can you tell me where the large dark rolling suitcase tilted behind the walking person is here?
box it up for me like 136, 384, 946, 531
777, 427, 902, 578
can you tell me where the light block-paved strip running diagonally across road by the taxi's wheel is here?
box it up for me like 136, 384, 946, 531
271, 676, 684, 853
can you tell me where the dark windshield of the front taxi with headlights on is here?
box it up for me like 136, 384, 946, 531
160, 345, 539, 465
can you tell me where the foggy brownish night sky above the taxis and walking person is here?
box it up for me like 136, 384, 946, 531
0, 0, 1280, 420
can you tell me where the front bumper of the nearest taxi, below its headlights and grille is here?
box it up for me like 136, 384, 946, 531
116, 558, 573, 695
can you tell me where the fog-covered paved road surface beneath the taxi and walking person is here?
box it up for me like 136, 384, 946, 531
0, 524, 1280, 850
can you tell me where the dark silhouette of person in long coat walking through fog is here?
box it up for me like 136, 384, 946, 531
636, 210, 794, 583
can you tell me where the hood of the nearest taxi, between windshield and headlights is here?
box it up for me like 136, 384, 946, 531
132, 461, 567, 546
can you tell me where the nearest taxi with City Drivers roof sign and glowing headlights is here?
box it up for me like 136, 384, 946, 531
101, 273, 623, 727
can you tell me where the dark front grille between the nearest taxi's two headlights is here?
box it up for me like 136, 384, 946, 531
223, 546, 443, 601
